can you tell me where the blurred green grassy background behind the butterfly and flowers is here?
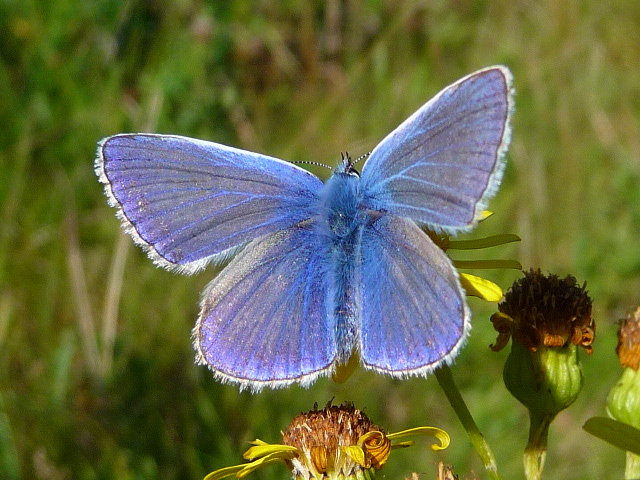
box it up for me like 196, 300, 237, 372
0, 0, 640, 480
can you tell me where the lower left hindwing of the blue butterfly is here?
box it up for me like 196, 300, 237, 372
193, 222, 337, 391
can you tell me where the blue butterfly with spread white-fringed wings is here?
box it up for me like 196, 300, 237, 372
95, 66, 513, 391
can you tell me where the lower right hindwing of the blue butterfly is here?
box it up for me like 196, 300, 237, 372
360, 215, 471, 378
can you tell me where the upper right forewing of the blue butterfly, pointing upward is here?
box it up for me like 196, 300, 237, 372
362, 66, 513, 233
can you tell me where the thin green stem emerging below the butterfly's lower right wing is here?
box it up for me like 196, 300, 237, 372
436, 365, 502, 480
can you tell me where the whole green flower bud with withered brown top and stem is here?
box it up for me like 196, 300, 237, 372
491, 270, 595, 479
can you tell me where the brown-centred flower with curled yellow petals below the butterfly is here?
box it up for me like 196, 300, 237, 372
205, 402, 449, 480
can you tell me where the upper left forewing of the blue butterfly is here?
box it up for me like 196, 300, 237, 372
95, 134, 323, 274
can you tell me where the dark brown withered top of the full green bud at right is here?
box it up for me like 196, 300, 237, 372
491, 270, 596, 354
